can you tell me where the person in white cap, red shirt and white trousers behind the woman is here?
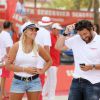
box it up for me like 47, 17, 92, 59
42, 23, 63, 100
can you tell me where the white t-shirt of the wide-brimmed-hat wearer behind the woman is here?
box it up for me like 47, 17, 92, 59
35, 27, 51, 68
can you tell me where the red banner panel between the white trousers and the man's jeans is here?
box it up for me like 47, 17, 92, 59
56, 65, 74, 94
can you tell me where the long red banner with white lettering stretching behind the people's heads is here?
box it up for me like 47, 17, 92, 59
26, 7, 93, 26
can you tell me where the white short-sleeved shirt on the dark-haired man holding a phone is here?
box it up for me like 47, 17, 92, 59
65, 35, 100, 84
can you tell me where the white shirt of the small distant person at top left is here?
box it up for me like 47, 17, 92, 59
15, 1, 26, 15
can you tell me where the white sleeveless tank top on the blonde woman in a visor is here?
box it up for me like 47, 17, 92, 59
14, 41, 39, 77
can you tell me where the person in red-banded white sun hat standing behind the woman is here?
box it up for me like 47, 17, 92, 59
35, 16, 52, 100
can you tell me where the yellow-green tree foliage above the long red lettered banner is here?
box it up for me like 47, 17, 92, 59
44, 0, 97, 11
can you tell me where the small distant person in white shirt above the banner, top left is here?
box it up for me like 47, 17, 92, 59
15, 0, 26, 15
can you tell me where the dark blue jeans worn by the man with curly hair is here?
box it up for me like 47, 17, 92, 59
68, 78, 100, 100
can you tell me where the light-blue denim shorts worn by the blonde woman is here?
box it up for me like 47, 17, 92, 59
10, 77, 42, 93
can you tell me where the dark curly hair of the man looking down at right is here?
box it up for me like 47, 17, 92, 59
75, 20, 93, 31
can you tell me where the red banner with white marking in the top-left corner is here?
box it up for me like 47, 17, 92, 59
0, 0, 17, 24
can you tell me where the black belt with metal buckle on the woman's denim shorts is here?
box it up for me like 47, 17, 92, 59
14, 74, 39, 82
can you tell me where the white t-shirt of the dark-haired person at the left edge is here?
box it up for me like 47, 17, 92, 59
0, 31, 13, 75
